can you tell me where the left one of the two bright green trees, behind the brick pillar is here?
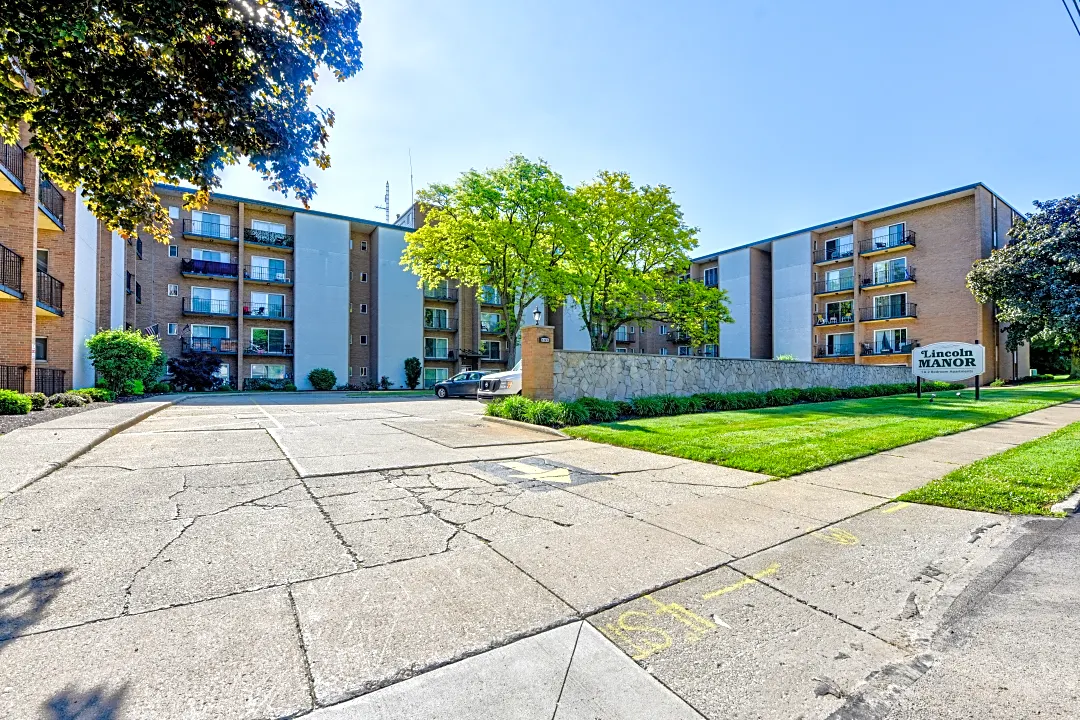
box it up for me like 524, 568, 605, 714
402, 155, 568, 362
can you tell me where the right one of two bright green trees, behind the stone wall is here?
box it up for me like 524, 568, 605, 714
563, 172, 731, 350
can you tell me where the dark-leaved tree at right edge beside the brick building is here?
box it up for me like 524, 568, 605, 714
968, 195, 1080, 377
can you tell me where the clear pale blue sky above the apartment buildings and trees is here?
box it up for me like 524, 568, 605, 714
222, 0, 1080, 253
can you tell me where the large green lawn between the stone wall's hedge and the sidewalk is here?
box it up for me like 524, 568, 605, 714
565, 383, 1080, 477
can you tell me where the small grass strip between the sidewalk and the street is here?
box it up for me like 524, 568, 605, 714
900, 422, 1080, 515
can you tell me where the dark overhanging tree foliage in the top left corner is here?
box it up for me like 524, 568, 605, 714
0, 0, 361, 240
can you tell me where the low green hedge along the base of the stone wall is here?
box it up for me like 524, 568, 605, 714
486, 382, 966, 427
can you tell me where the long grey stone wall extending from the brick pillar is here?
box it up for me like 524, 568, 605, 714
554, 350, 915, 400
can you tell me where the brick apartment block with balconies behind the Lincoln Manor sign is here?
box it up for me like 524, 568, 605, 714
680, 182, 1029, 381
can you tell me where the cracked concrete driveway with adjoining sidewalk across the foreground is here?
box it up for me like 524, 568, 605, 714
0, 394, 1080, 720
